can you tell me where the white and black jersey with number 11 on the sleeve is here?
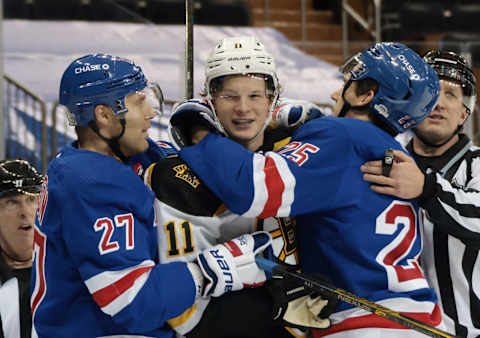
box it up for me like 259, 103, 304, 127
144, 156, 297, 335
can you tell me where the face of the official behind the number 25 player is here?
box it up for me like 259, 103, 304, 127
415, 80, 467, 144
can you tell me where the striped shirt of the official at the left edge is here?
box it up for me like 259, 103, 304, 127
0, 256, 32, 338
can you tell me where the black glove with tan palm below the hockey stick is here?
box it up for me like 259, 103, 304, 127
266, 266, 338, 330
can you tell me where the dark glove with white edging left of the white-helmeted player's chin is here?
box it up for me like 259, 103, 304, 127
168, 99, 225, 150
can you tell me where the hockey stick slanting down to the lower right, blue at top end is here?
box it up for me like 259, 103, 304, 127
255, 256, 455, 338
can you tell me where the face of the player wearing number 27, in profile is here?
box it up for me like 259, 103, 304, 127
119, 92, 155, 157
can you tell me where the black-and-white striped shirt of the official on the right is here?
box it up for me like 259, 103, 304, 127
407, 134, 480, 338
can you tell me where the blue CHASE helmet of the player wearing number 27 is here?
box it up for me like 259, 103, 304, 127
60, 54, 147, 126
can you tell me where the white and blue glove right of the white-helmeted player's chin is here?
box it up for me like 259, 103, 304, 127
272, 98, 325, 127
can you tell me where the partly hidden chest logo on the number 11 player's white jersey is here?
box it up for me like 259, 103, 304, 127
257, 217, 298, 265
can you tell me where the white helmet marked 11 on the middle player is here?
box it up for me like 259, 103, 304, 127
204, 36, 280, 137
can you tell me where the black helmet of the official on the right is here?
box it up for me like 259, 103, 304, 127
423, 50, 477, 113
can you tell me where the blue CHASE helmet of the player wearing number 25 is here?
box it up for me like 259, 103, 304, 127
350, 42, 440, 133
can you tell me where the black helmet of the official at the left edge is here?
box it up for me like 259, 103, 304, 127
0, 159, 43, 198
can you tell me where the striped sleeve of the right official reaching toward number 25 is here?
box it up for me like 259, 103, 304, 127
418, 151, 480, 247
